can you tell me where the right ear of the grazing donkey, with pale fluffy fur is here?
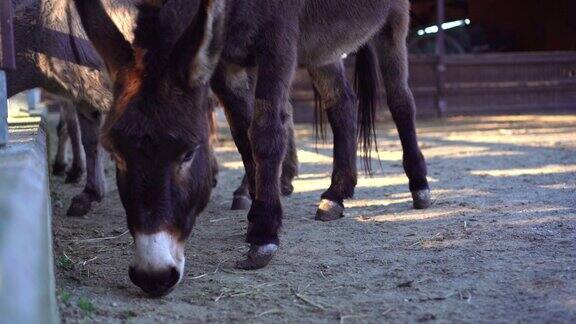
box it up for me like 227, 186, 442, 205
173, 0, 226, 86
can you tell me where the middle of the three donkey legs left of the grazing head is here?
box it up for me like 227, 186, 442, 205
62, 101, 84, 183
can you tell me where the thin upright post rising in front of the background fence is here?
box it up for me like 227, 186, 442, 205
436, 0, 446, 116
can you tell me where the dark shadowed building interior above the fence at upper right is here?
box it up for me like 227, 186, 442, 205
411, 0, 576, 53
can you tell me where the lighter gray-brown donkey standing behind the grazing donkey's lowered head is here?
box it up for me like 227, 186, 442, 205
7, 0, 298, 216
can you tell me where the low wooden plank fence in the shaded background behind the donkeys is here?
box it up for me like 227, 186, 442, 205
292, 52, 576, 122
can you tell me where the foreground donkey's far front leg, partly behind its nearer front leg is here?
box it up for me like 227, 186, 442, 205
212, 62, 255, 210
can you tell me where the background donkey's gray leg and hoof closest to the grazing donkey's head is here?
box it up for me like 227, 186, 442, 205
67, 110, 106, 216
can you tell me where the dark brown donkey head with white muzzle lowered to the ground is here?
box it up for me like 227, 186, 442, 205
75, 0, 223, 295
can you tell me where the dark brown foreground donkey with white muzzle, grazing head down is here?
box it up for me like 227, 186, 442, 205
75, 0, 430, 294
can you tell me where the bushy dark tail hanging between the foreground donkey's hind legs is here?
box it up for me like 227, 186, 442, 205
354, 43, 382, 174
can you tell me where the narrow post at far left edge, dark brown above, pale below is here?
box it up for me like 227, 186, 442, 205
0, 0, 16, 147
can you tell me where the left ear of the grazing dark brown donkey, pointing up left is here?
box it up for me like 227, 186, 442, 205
74, 0, 134, 79
